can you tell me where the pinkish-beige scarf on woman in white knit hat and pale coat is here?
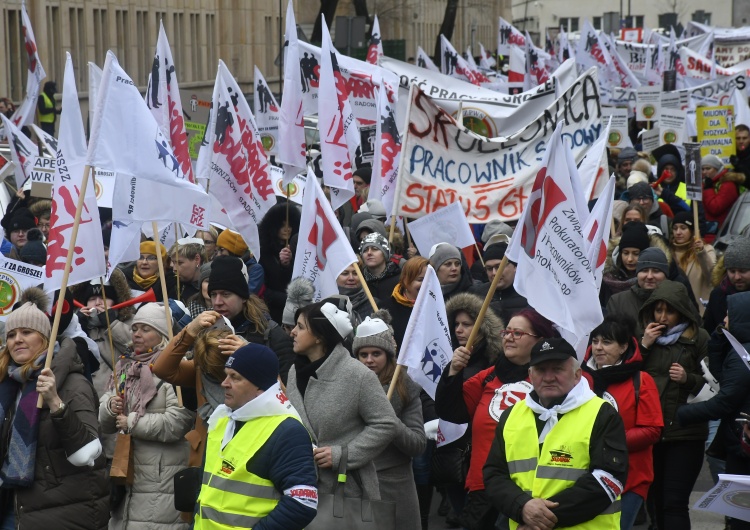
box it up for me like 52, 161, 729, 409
115, 350, 159, 428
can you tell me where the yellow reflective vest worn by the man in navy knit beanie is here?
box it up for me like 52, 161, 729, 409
195, 414, 297, 530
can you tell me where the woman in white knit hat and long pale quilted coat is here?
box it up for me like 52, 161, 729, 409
99, 303, 193, 530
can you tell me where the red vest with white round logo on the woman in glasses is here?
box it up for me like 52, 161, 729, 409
463, 366, 532, 491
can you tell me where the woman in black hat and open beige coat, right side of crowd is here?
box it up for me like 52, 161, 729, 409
669, 212, 716, 316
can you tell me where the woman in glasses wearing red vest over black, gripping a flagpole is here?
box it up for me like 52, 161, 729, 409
435, 306, 557, 530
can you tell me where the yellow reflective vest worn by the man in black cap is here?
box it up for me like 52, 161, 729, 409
503, 397, 620, 530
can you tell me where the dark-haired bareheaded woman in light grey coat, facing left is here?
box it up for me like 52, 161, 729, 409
287, 302, 399, 506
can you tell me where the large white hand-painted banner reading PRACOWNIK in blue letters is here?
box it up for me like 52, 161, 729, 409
394, 69, 603, 223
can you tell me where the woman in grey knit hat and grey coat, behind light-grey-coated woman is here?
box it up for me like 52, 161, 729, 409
352, 309, 427, 530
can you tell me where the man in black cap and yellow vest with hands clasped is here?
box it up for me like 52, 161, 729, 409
484, 338, 628, 530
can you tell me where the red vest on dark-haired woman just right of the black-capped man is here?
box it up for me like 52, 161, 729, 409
583, 339, 664, 499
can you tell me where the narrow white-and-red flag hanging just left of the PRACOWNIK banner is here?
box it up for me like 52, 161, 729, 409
369, 86, 401, 217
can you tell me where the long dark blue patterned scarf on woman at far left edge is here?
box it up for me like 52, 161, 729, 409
0, 353, 47, 488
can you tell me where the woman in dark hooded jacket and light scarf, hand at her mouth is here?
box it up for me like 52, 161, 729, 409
640, 280, 709, 530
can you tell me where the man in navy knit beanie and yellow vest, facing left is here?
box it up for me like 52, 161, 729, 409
195, 343, 318, 530
